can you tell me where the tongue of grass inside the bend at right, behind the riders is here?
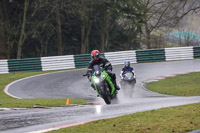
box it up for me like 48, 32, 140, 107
146, 72, 200, 96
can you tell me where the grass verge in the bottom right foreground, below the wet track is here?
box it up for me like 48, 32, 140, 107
49, 103, 200, 133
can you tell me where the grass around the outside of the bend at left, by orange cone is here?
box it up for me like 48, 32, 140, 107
0, 71, 89, 108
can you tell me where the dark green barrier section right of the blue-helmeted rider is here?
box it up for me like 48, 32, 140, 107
136, 49, 165, 63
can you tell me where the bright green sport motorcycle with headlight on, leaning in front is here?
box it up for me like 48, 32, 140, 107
83, 65, 117, 104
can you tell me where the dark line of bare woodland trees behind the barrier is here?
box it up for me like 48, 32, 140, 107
0, 0, 200, 59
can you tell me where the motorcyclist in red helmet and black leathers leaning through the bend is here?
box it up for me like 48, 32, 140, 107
87, 50, 120, 90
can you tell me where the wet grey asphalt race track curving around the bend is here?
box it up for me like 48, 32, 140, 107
0, 60, 200, 133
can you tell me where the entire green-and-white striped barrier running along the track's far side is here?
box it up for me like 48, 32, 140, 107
0, 46, 200, 74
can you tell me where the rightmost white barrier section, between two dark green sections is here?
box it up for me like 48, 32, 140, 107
165, 47, 194, 61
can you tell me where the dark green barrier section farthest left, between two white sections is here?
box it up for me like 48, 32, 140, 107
8, 58, 42, 72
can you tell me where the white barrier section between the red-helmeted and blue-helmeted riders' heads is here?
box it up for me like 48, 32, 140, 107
104, 50, 136, 65
